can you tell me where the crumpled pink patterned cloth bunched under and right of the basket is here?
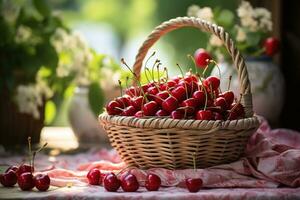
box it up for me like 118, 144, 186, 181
41, 118, 300, 188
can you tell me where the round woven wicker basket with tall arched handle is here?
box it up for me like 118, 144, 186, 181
99, 17, 259, 169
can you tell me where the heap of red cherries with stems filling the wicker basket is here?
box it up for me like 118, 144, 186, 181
106, 49, 245, 120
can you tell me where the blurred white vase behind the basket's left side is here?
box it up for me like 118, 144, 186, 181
68, 86, 107, 146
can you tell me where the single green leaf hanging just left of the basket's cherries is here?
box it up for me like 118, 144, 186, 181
88, 82, 105, 116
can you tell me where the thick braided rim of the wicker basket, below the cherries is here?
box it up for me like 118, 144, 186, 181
98, 112, 259, 130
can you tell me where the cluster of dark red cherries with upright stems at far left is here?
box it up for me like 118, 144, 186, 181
0, 139, 50, 191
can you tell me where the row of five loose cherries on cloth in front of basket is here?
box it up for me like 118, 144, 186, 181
87, 168, 202, 192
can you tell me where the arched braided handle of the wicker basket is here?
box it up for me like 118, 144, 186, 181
133, 17, 253, 117
